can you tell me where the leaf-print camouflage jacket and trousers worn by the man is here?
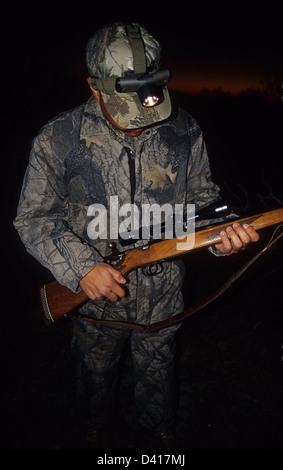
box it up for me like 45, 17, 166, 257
14, 97, 222, 429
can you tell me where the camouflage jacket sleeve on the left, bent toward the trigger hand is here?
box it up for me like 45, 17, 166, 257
14, 128, 102, 292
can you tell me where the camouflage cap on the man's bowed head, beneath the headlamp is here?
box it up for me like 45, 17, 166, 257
86, 23, 171, 129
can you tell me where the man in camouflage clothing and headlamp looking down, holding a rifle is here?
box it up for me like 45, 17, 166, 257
15, 23, 259, 446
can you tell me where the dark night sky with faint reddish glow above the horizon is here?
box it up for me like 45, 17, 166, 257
7, 1, 282, 104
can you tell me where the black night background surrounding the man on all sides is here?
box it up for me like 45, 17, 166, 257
0, 2, 283, 451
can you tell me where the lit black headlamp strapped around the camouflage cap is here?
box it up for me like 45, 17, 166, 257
91, 69, 171, 107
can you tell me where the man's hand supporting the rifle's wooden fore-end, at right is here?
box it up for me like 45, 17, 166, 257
215, 222, 259, 255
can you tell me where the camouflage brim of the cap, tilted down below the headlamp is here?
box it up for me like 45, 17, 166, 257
101, 87, 172, 129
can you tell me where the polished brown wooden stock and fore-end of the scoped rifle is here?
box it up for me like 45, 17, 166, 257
40, 208, 283, 325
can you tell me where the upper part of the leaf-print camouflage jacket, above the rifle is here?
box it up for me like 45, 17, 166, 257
14, 97, 222, 291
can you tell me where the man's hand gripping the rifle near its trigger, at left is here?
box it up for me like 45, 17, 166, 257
80, 263, 127, 302
